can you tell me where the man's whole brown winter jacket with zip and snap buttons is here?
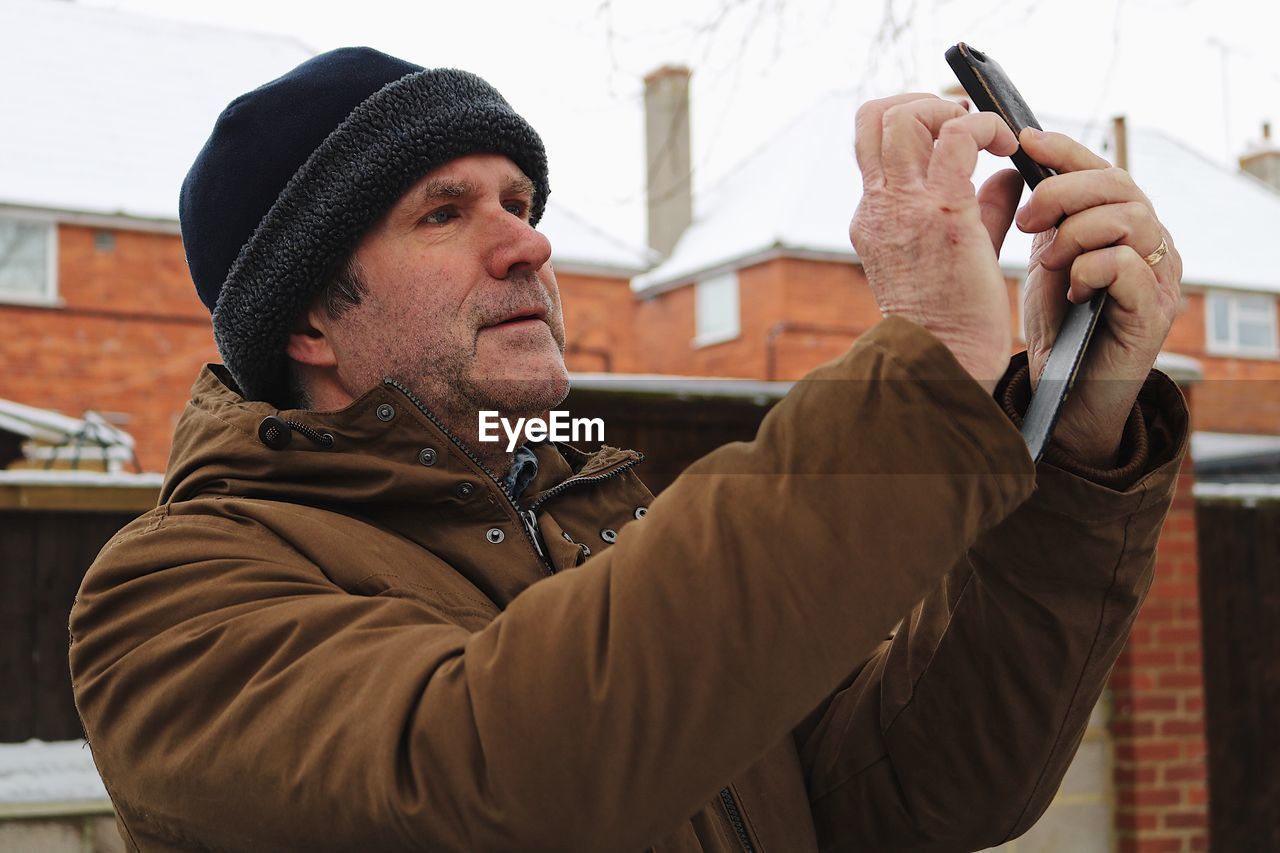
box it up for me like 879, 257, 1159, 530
70, 319, 1187, 853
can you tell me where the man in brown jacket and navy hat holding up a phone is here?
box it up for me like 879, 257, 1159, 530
70, 49, 1187, 852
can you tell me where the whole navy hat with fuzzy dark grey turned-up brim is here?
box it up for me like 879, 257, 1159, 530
178, 47, 550, 405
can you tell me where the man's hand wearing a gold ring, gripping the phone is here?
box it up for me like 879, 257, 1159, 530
1015, 128, 1183, 467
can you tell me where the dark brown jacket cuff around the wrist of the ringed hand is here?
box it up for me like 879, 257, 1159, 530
995, 352, 1189, 492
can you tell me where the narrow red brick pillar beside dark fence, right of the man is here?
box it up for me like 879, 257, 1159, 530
1111, 462, 1208, 853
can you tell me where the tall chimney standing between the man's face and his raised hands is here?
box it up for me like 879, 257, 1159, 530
644, 65, 694, 257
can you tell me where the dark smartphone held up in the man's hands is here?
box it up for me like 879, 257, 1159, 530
946, 42, 1107, 461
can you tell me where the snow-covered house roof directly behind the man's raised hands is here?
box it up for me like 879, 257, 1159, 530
631, 92, 1280, 292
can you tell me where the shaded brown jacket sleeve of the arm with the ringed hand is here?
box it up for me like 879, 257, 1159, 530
795, 357, 1188, 850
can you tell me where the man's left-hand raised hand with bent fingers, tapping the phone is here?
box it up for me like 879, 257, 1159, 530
849, 93, 1021, 392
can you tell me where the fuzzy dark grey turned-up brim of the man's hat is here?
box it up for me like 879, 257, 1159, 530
214, 69, 549, 405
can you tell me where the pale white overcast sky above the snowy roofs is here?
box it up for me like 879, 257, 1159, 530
77, 0, 1280, 243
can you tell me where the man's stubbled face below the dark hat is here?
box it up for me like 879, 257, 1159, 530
320, 155, 568, 420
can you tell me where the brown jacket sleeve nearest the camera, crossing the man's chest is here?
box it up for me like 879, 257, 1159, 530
70, 319, 1034, 850
